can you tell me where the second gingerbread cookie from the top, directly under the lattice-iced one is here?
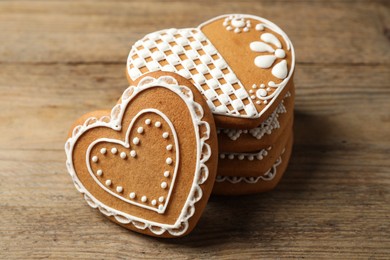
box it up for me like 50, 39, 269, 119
217, 87, 295, 153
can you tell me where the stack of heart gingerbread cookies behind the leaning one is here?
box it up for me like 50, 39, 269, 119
127, 15, 295, 195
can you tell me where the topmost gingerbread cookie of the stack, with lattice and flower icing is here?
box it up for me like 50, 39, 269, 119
127, 14, 295, 129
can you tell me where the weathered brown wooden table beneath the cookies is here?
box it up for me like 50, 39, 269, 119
0, 0, 390, 259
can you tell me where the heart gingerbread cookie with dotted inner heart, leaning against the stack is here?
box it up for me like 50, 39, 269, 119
65, 73, 218, 237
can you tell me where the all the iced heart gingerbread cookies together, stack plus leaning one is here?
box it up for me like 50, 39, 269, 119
65, 15, 295, 237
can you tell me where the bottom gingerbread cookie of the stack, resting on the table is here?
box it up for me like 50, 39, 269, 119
213, 135, 293, 196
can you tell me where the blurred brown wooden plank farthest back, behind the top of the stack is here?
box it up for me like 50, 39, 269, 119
0, 1, 390, 64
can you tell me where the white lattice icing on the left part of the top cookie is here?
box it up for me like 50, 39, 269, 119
128, 29, 258, 117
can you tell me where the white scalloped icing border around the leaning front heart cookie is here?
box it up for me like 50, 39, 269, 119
65, 76, 211, 236
